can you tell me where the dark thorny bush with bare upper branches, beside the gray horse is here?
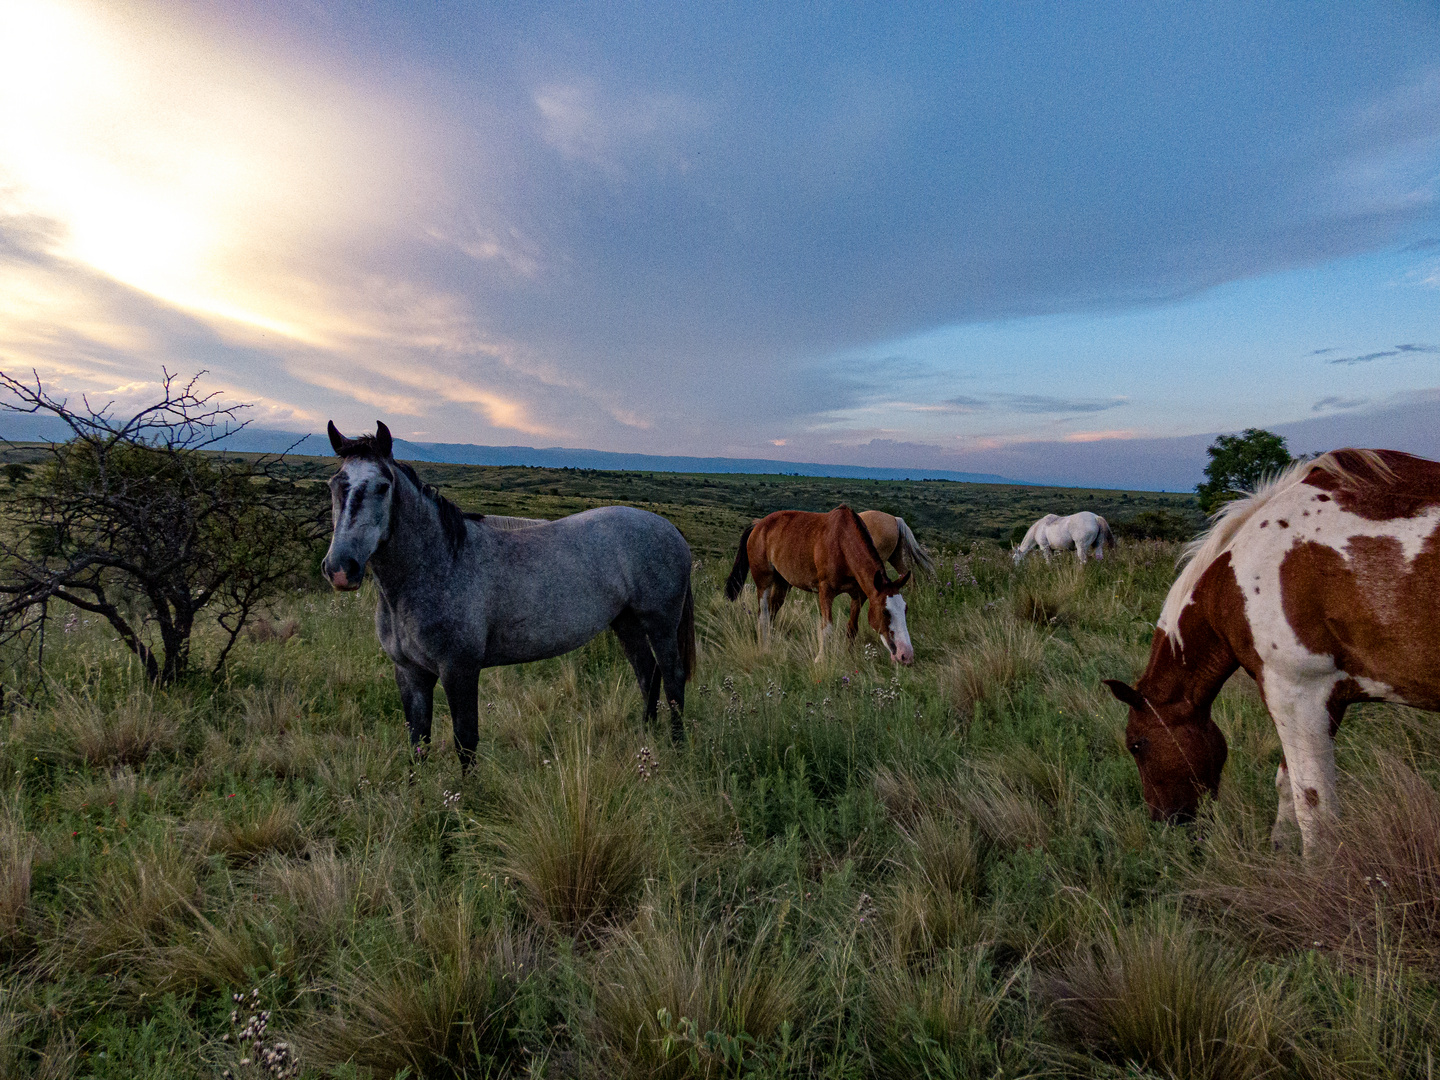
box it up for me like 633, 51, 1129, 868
0, 372, 324, 683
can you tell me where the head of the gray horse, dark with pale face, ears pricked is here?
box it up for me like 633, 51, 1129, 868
320, 422, 395, 592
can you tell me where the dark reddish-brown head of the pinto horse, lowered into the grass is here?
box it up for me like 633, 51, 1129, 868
1104, 678, 1228, 822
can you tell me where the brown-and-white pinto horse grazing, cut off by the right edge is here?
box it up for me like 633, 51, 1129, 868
1106, 449, 1440, 854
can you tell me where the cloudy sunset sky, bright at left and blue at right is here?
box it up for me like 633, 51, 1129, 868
0, 0, 1440, 487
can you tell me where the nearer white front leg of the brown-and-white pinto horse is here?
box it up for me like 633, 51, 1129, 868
1263, 670, 1339, 858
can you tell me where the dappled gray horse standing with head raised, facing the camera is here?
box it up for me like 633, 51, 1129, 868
320, 423, 696, 768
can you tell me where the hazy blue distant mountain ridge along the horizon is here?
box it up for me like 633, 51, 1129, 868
0, 416, 1030, 485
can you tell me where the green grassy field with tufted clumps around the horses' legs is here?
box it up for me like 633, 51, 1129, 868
0, 467, 1440, 1080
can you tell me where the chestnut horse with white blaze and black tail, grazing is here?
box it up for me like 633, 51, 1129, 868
724, 505, 914, 664
